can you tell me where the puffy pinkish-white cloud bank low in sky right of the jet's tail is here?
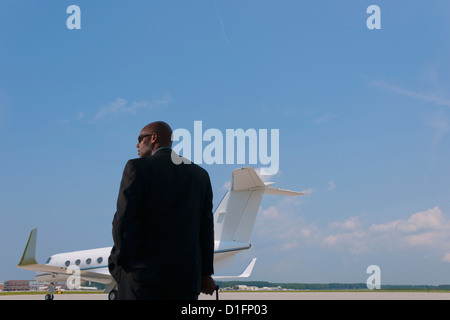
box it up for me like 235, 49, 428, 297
255, 198, 450, 262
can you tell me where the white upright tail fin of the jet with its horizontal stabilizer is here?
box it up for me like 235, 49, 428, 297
214, 167, 305, 243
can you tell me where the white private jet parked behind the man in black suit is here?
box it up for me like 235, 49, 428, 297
17, 167, 305, 300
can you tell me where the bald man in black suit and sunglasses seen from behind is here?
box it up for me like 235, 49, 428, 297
108, 121, 216, 300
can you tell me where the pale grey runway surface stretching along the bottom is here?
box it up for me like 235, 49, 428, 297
0, 291, 450, 301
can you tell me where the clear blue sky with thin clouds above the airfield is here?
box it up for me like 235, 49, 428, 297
0, 0, 450, 284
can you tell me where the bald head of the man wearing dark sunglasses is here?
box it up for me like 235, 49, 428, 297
136, 121, 172, 157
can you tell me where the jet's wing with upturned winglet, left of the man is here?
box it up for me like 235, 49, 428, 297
17, 228, 112, 284
